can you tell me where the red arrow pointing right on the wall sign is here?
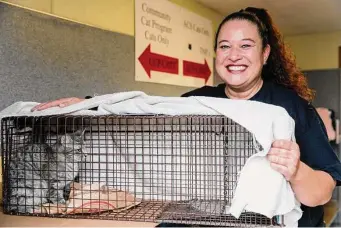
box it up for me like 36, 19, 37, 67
183, 59, 211, 84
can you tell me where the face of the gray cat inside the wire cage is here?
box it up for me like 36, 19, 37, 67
59, 130, 87, 160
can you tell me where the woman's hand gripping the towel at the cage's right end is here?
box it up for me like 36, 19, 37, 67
267, 140, 300, 181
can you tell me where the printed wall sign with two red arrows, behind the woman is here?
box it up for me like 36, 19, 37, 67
135, 0, 214, 87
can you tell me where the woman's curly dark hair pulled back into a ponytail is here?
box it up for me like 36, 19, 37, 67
214, 7, 315, 102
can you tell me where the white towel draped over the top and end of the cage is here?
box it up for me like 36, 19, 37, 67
0, 91, 302, 226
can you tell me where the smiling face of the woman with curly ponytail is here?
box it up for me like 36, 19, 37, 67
215, 20, 270, 89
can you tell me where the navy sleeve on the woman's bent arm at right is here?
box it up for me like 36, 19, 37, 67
295, 104, 341, 186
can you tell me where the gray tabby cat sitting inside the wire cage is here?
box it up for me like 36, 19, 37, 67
9, 131, 86, 213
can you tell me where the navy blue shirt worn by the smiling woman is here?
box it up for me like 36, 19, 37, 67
182, 82, 341, 227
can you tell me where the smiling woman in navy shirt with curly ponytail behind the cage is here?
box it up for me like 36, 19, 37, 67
178, 7, 341, 227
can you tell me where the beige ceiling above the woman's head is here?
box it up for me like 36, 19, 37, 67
197, 0, 341, 35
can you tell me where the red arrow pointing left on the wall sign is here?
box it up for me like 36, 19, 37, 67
139, 44, 179, 78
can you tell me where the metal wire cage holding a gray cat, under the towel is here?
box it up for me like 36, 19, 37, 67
1, 115, 283, 227
